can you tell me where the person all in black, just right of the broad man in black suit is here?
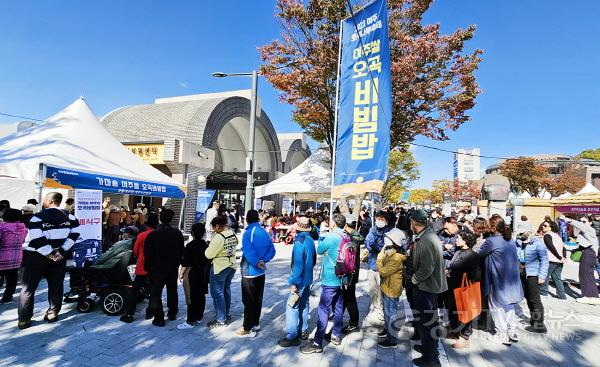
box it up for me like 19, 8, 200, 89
177, 223, 211, 330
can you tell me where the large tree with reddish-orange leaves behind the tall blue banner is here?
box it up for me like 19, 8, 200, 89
259, 0, 482, 157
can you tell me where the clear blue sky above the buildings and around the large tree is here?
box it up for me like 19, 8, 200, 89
0, 0, 600, 187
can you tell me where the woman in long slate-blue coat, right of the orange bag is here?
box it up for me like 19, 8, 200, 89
477, 214, 524, 345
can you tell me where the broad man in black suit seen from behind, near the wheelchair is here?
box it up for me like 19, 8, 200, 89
144, 209, 184, 327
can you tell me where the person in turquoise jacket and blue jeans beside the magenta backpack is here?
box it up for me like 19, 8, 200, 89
300, 213, 350, 354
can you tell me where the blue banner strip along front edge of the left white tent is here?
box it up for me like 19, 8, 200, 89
44, 166, 185, 199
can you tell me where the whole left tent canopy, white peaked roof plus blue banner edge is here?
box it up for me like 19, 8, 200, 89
0, 98, 185, 198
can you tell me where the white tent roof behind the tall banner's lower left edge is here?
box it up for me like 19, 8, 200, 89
255, 149, 331, 201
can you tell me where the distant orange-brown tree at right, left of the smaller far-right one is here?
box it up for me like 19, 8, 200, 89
500, 157, 549, 197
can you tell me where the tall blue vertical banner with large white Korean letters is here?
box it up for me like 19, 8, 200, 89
333, 0, 392, 197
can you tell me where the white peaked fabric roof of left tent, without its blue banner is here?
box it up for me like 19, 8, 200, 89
0, 98, 182, 193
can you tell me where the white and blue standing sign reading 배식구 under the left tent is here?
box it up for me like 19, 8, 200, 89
73, 189, 102, 267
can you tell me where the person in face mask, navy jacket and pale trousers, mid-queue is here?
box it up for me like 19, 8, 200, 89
365, 211, 391, 327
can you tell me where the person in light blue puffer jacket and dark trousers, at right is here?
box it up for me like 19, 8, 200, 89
517, 225, 549, 333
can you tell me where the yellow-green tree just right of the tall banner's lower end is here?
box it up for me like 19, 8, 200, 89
381, 149, 420, 203
